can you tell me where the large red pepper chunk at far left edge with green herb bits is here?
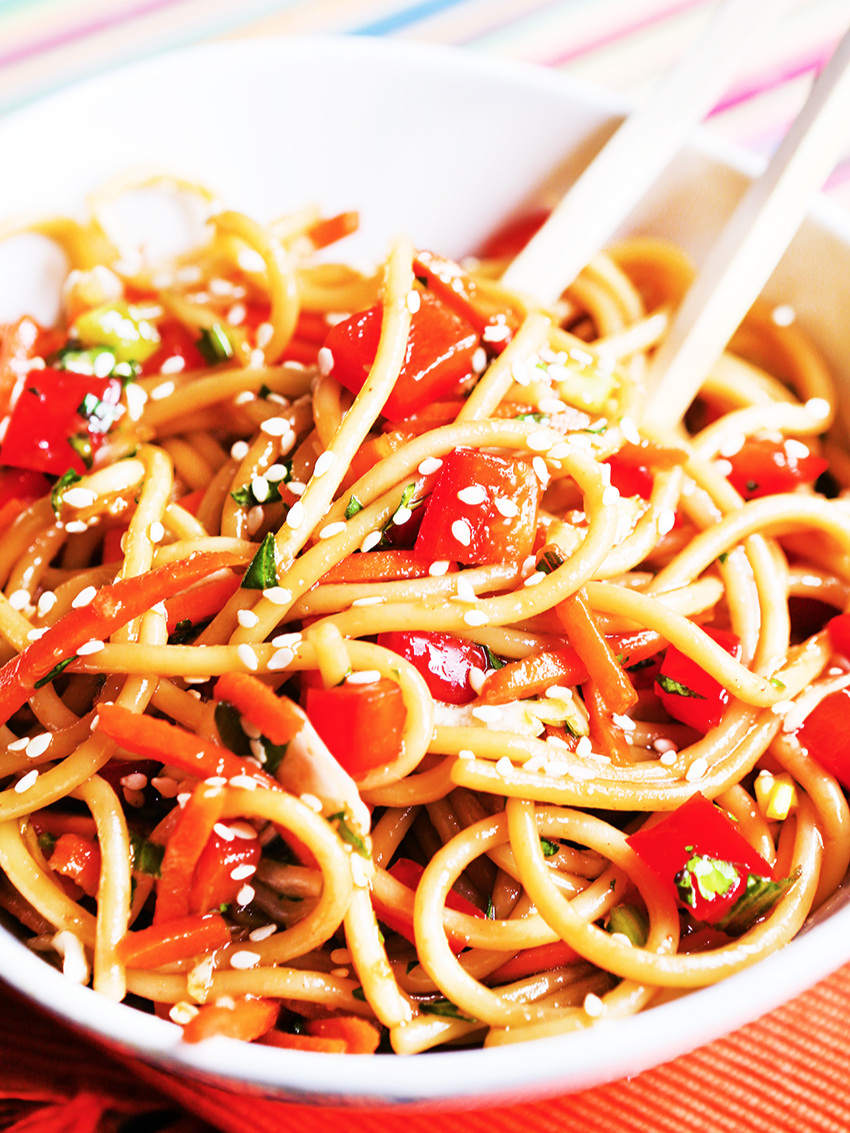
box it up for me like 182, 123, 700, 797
0, 368, 121, 476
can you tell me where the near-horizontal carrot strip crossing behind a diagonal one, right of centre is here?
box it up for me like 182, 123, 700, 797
479, 630, 665, 705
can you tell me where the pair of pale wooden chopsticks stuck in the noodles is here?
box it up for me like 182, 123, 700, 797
502, 0, 850, 429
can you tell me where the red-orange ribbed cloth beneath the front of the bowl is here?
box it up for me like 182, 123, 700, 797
0, 965, 850, 1133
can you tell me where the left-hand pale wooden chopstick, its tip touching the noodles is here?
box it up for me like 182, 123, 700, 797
502, 0, 793, 305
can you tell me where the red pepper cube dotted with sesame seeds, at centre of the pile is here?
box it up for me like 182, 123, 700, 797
414, 449, 541, 563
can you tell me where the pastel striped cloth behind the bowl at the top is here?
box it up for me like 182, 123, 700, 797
0, 0, 850, 207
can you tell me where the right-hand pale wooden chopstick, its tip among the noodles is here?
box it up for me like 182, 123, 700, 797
646, 32, 850, 429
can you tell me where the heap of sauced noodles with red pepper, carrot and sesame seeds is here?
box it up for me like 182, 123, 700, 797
0, 176, 850, 1054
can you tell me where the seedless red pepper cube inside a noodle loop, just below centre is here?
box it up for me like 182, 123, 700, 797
305, 678, 407, 778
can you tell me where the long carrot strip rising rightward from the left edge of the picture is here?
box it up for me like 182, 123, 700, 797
0, 552, 244, 722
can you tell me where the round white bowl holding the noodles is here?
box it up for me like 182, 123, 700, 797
0, 39, 850, 1106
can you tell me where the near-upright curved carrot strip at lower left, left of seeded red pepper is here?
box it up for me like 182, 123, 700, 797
153, 783, 224, 925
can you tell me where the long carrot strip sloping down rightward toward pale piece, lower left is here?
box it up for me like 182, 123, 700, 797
96, 704, 280, 790
